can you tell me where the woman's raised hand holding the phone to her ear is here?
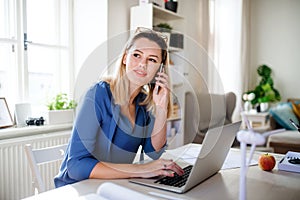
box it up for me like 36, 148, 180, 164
153, 72, 170, 109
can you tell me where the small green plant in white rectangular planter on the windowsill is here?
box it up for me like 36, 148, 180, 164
47, 93, 77, 124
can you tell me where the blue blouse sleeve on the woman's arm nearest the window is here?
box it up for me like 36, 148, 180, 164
67, 83, 105, 181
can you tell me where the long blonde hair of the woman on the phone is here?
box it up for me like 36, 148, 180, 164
102, 30, 172, 117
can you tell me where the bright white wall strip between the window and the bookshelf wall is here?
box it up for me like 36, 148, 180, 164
73, 0, 108, 102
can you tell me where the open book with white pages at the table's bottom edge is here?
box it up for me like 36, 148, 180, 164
79, 182, 156, 200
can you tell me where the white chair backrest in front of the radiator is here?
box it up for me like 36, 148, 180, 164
24, 144, 67, 193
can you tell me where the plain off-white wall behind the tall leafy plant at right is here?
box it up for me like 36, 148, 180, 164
250, 0, 300, 101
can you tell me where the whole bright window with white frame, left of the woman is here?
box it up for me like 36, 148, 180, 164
0, 0, 74, 112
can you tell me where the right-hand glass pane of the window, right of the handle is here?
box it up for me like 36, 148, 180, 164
24, 0, 70, 103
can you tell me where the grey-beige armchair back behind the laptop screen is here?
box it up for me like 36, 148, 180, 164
185, 92, 236, 144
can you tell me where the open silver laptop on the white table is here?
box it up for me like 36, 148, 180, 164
129, 121, 241, 193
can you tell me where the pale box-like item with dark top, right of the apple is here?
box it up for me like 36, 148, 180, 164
278, 151, 300, 173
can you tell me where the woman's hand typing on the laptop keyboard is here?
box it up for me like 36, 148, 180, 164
136, 158, 184, 178
